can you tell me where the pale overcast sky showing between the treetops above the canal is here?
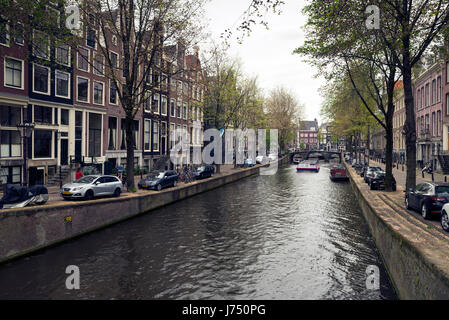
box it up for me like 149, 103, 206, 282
206, 0, 324, 122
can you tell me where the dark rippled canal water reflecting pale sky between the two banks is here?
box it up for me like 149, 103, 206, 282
0, 165, 396, 300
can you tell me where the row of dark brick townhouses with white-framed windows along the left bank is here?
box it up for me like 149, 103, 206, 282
0, 13, 204, 185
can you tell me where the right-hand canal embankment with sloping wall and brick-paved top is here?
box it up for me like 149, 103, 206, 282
346, 165, 449, 300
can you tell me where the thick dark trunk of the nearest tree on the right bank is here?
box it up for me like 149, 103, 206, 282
402, 54, 416, 190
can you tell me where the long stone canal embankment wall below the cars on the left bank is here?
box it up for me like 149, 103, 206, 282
0, 157, 290, 263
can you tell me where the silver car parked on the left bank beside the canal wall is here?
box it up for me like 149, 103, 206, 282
61, 176, 123, 200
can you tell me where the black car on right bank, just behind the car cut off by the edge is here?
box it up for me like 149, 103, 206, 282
405, 182, 449, 219
